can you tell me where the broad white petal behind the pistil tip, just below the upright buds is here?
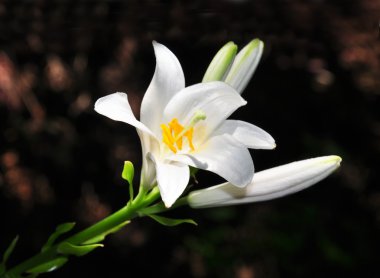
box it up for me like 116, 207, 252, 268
164, 81, 247, 140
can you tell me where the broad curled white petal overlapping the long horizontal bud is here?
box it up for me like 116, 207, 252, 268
170, 134, 254, 187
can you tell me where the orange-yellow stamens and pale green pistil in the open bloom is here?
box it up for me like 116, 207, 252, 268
161, 111, 206, 153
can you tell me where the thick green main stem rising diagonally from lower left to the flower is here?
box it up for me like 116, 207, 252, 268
4, 188, 159, 277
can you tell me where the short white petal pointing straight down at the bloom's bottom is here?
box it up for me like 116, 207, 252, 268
150, 153, 190, 207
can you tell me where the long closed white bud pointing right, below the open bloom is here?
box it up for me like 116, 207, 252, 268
188, 155, 342, 208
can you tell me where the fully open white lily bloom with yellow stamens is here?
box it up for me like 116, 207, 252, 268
95, 42, 275, 207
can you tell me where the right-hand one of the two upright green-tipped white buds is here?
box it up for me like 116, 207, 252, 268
224, 39, 264, 94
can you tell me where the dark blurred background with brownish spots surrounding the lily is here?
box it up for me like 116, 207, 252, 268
0, 0, 380, 278
